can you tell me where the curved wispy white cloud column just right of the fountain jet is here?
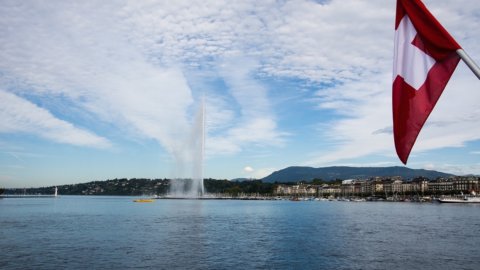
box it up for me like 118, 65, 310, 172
207, 57, 285, 154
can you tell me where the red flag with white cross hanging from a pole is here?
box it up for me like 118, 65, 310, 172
392, 0, 461, 164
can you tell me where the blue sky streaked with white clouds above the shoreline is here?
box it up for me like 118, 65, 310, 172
0, 0, 480, 187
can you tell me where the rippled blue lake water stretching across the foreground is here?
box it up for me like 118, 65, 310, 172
0, 196, 480, 269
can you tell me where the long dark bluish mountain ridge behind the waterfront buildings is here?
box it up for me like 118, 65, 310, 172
262, 166, 453, 183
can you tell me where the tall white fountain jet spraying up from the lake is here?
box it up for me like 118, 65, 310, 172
170, 99, 205, 198
